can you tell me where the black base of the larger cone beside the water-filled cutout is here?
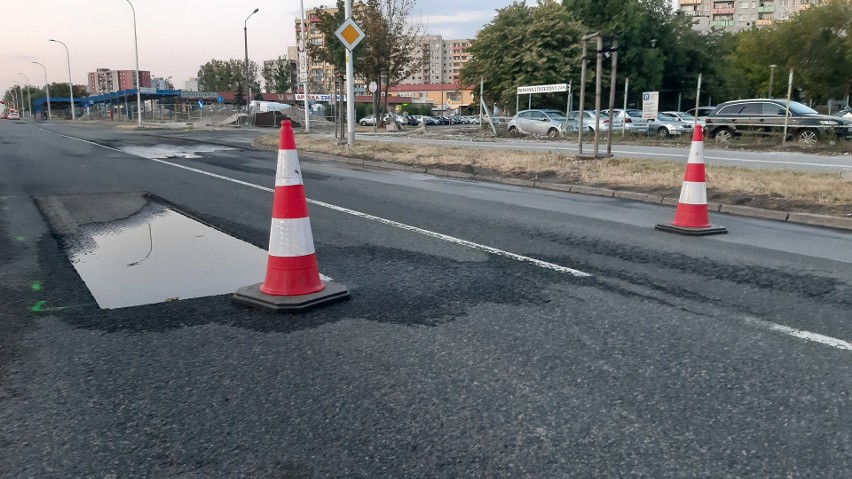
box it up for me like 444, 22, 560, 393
233, 281, 349, 313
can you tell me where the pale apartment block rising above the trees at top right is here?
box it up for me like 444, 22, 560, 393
678, 0, 824, 32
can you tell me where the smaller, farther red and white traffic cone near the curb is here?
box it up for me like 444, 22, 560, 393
656, 125, 728, 236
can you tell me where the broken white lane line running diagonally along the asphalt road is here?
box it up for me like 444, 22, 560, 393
50, 130, 852, 351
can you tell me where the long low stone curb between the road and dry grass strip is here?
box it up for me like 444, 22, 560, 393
292, 152, 852, 231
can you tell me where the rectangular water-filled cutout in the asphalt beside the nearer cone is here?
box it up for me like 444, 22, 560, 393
36, 193, 267, 309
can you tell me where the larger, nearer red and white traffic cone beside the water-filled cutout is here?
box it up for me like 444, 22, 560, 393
233, 120, 349, 312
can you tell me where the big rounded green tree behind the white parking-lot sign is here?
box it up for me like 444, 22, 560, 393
461, 0, 583, 111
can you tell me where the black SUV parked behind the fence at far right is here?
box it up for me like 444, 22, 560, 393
706, 98, 852, 146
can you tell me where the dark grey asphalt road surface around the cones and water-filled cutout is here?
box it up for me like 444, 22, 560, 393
0, 122, 852, 478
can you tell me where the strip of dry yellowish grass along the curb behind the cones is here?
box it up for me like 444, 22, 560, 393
257, 135, 852, 216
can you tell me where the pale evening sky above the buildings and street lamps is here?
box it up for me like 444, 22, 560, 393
0, 0, 513, 92
